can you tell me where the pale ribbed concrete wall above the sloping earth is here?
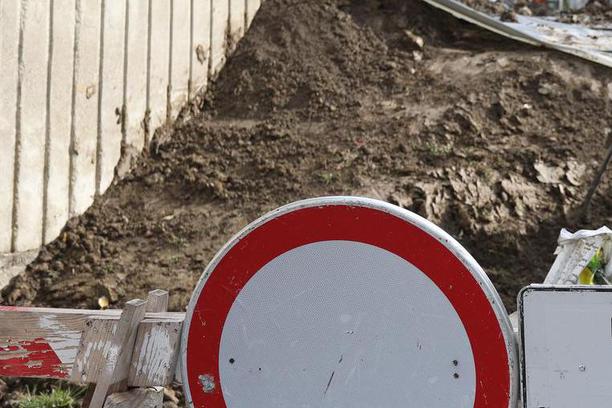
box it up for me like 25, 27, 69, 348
0, 0, 260, 287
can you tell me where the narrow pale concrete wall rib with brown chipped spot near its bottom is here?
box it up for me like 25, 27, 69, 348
189, 0, 211, 98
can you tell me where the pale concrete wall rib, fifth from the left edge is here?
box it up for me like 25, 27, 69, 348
96, 0, 126, 194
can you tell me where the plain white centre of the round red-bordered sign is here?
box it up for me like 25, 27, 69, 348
219, 241, 478, 408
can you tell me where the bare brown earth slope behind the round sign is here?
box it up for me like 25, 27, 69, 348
2, 0, 612, 402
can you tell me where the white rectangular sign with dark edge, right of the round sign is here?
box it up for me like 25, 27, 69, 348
519, 285, 612, 408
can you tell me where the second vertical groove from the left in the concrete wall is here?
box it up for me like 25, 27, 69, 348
42, 0, 55, 244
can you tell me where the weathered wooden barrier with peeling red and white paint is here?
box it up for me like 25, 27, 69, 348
0, 290, 185, 408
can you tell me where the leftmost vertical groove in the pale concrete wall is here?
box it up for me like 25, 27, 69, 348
11, 0, 28, 252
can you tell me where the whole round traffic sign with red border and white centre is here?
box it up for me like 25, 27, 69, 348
181, 197, 518, 408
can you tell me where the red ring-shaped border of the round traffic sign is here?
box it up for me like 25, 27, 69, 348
184, 204, 511, 408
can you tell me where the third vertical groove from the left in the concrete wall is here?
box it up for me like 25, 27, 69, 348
68, 0, 81, 218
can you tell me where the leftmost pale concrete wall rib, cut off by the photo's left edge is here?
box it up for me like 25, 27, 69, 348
0, 1, 20, 253
